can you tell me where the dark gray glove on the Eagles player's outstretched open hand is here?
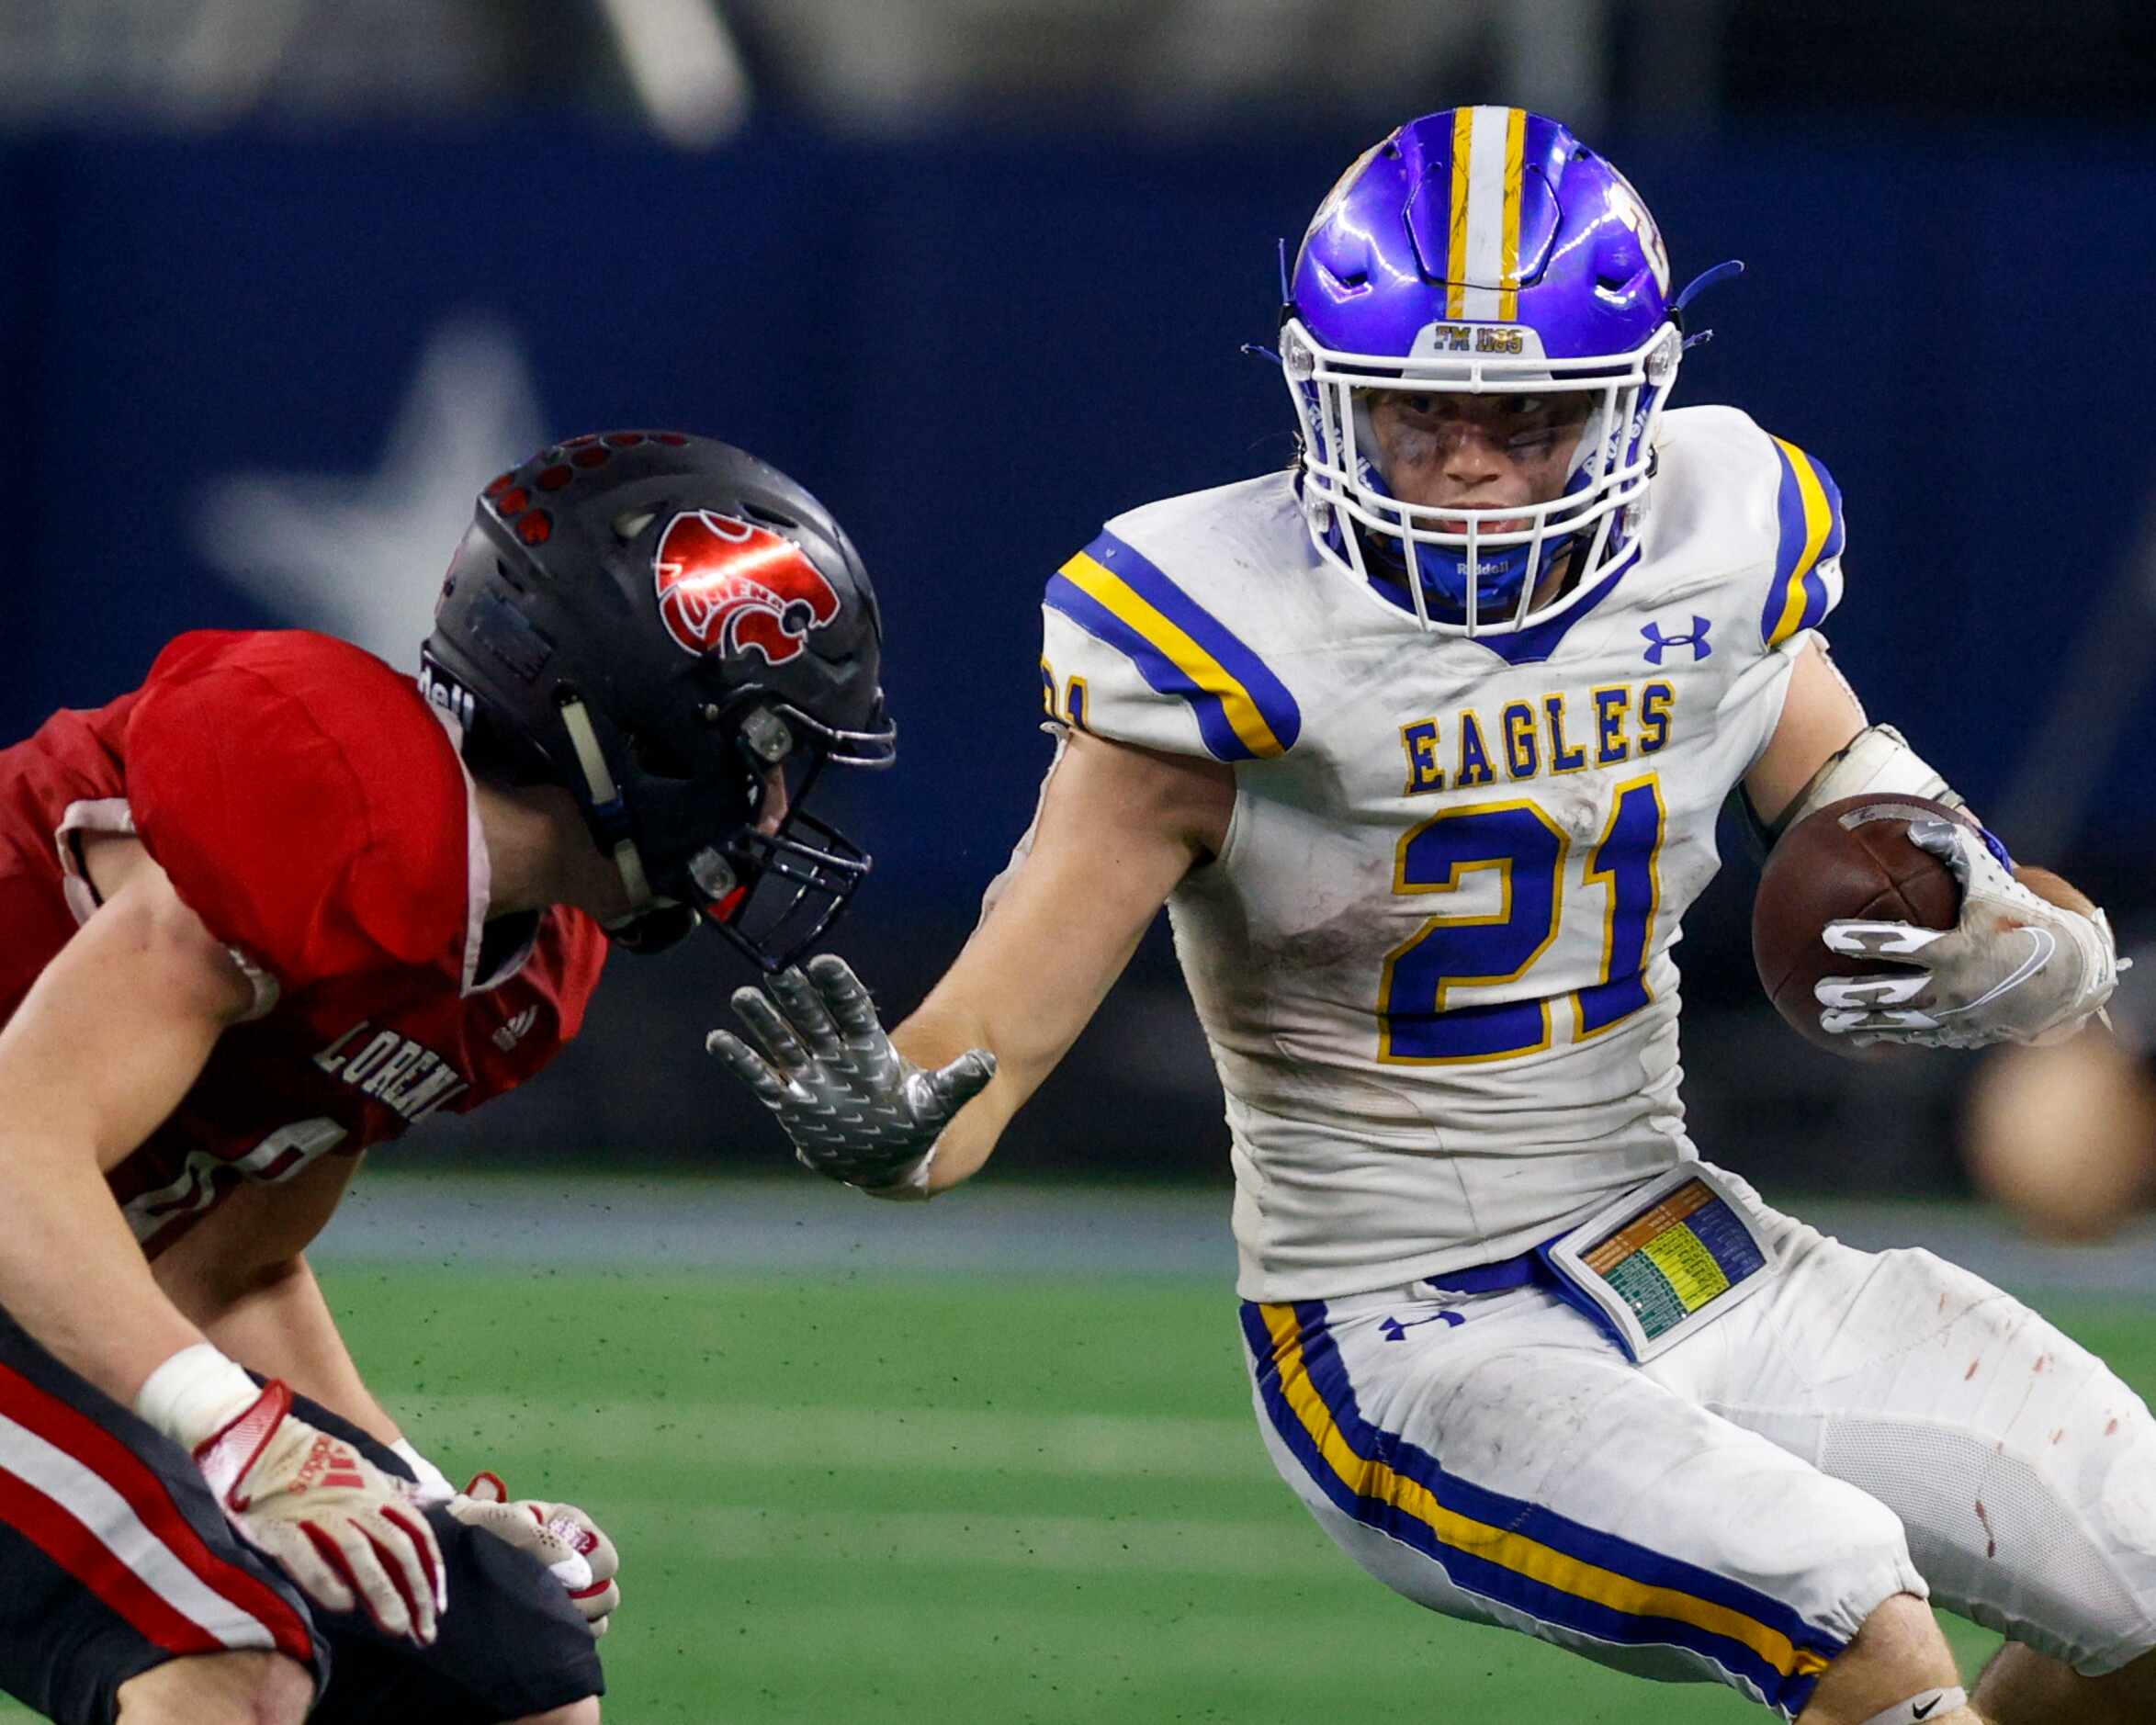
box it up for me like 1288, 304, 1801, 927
705, 953, 996, 1197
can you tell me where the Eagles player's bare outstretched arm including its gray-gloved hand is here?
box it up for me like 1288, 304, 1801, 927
714, 735, 1236, 1197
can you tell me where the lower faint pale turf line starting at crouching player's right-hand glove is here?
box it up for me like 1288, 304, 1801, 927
608, 1496, 1326, 1576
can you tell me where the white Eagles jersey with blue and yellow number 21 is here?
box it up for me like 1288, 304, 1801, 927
1042, 408, 1841, 1301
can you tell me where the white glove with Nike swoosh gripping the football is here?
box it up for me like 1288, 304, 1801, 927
1813, 819, 2119, 1048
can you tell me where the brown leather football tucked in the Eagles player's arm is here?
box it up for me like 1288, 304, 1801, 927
1753, 792, 1969, 1059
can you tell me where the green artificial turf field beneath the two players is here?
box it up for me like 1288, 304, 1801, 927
0, 1264, 2156, 1725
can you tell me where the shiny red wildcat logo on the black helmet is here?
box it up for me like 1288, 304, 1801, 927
651, 509, 839, 664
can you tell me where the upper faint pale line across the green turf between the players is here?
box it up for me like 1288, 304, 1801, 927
390, 1392, 1272, 1482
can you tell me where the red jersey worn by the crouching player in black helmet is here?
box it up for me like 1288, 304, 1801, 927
0, 632, 606, 1255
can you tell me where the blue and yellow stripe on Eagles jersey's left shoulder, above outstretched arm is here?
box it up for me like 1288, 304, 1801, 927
1044, 533, 1303, 761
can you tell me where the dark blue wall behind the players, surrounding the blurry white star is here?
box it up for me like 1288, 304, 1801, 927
0, 120, 2156, 1167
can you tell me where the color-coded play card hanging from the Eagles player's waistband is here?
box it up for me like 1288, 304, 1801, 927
1541, 1162, 1775, 1360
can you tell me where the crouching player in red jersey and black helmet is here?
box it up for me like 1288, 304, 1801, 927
0, 434, 893, 1725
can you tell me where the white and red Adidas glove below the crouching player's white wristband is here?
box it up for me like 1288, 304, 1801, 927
194, 1378, 448, 1647
